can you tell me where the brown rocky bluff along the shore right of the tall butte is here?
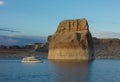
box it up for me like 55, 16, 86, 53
93, 38, 120, 58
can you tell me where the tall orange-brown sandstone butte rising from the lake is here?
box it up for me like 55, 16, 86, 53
48, 18, 94, 60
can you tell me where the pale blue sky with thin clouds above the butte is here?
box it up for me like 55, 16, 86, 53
0, 0, 120, 36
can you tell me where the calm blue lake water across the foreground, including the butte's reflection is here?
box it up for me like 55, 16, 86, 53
0, 59, 120, 82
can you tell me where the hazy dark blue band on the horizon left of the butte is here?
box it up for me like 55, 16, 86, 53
0, 35, 47, 46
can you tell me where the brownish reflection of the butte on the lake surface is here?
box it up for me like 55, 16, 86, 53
49, 60, 89, 82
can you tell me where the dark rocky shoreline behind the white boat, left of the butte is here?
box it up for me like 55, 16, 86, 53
0, 43, 48, 58
